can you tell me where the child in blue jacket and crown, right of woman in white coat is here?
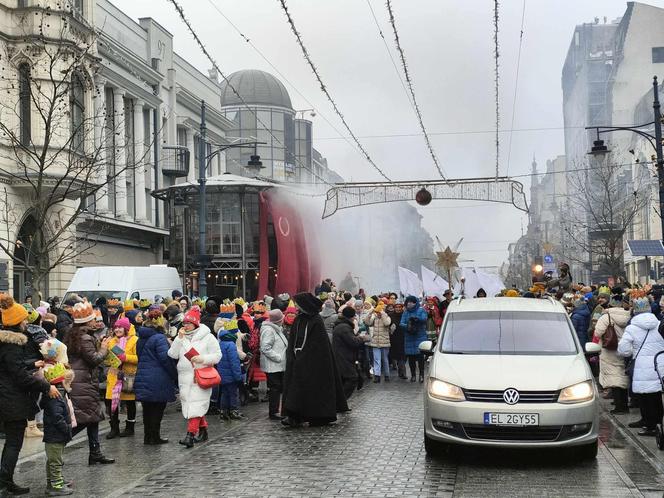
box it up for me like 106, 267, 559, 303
217, 320, 243, 420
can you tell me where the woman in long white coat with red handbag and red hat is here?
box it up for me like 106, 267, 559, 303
168, 306, 221, 448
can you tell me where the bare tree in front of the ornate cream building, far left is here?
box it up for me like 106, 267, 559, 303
0, 3, 148, 301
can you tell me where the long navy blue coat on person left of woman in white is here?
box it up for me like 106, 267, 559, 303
134, 327, 178, 403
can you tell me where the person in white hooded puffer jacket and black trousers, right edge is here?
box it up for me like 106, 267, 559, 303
618, 298, 664, 436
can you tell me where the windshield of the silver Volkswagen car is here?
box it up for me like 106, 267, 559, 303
440, 311, 577, 355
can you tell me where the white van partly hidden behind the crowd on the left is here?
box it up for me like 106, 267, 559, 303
65, 265, 182, 303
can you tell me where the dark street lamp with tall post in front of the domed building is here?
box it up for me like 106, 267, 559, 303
198, 100, 265, 297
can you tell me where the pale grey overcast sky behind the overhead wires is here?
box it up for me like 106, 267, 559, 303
114, 0, 664, 266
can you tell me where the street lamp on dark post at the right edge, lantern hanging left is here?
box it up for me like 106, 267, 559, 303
586, 76, 664, 243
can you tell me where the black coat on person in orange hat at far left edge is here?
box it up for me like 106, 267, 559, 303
0, 330, 51, 422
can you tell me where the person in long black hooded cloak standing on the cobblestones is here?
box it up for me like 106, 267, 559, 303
282, 292, 349, 427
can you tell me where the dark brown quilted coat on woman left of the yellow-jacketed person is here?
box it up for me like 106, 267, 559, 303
65, 324, 107, 425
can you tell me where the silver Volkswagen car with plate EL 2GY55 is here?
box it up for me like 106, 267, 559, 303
420, 297, 601, 459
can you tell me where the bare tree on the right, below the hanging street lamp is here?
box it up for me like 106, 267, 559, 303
563, 159, 652, 279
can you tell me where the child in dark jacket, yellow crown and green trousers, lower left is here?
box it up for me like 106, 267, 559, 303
40, 364, 74, 496
